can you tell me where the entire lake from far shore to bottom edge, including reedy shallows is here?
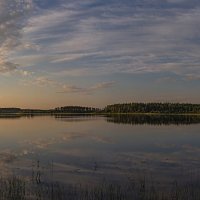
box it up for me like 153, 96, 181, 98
0, 115, 200, 199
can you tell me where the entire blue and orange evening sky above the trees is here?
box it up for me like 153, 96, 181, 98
0, 0, 200, 108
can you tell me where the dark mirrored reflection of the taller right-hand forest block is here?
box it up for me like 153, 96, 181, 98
107, 114, 200, 125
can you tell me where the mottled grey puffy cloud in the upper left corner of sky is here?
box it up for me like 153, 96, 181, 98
0, 0, 33, 73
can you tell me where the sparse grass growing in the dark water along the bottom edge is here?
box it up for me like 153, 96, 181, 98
0, 173, 200, 200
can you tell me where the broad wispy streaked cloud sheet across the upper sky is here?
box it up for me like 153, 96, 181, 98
8, 0, 200, 81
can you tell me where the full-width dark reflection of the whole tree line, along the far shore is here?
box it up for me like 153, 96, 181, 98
0, 113, 200, 125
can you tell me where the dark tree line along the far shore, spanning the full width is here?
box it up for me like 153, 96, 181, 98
0, 103, 200, 114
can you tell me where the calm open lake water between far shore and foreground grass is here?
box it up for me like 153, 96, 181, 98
0, 116, 200, 187
